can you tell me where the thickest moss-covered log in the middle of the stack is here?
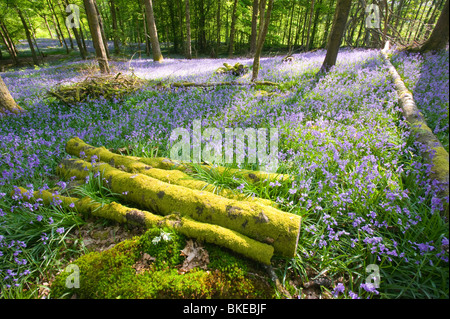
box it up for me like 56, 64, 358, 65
57, 159, 301, 257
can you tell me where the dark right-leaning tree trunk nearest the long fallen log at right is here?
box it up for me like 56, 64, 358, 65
321, 0, 352, 72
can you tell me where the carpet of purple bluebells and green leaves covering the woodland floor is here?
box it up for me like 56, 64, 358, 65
0, 40, 449, 298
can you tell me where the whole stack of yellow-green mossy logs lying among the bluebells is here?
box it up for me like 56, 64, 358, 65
17, 138, 301, 264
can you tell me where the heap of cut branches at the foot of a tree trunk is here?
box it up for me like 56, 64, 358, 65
47, 72, 144, 106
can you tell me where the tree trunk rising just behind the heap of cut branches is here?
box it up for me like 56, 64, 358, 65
83, 0, 110, 73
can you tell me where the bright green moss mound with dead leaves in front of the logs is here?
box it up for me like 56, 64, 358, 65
51, 228, 275, 299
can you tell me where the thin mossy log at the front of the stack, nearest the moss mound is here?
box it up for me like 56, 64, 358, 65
15, 188, 274, 265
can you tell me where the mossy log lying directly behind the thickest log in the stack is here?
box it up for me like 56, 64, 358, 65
66, 137, 277, 207
